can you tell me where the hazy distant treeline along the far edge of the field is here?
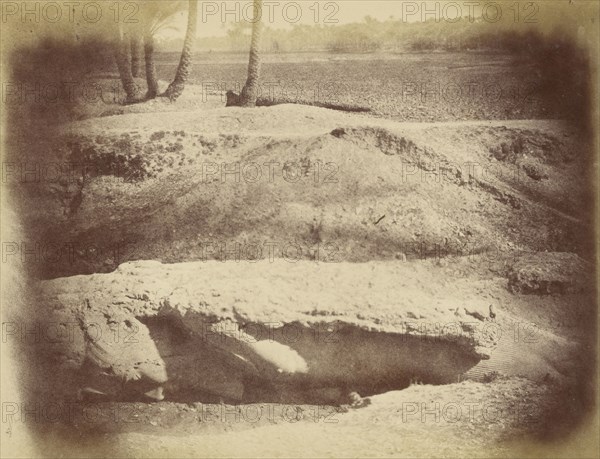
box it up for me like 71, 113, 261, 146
162, 16, 580, 53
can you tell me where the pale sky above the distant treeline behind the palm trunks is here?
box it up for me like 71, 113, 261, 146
161, 0, 599, 37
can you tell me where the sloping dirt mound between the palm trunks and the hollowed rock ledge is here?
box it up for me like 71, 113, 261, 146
12, 105, 591, 278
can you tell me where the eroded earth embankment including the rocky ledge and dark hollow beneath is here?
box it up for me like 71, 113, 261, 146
8, 102, 595, 454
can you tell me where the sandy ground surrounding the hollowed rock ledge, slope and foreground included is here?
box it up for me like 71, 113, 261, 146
2, 77, 596, 457
